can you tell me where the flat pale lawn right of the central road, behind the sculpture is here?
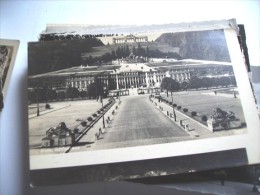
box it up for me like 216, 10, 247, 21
158, 89, 246, 129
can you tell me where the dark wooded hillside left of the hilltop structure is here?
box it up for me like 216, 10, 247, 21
28, 38, 104, 75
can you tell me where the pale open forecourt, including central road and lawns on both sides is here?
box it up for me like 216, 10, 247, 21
29, 89, 246, 154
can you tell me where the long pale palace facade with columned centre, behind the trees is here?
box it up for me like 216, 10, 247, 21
29, 59, 191, 91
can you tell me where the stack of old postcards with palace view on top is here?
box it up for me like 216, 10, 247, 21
28, 20, 260, 186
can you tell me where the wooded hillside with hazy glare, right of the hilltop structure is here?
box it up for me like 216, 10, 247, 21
155, 30, 230, 62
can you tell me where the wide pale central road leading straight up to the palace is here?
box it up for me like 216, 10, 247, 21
89, 95, 190, 149
